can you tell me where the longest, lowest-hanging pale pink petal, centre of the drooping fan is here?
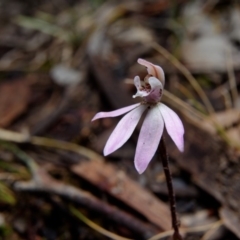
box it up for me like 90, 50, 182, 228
134, 106, 164, 174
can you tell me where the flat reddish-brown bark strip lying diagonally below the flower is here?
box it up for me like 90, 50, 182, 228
72, 160, 171, 230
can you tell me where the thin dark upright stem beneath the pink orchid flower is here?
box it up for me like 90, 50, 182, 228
158, 137, 183, 240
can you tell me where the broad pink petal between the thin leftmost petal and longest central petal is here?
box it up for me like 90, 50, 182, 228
103, 105, 147, 156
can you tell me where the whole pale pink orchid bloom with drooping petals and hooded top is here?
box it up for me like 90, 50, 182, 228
92, 59, 184, 174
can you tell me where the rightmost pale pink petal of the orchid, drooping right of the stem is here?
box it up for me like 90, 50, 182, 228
159, 103, 184, 152
